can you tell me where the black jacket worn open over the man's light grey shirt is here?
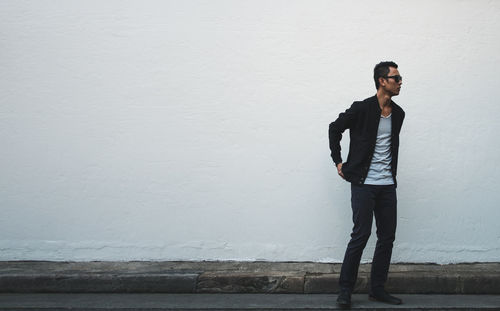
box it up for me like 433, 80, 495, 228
328, 95, 405, 185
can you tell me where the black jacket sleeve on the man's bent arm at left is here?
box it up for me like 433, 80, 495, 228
328, 102, 359, 166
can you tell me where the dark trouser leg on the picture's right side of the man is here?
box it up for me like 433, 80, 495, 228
371, 185, 397, 291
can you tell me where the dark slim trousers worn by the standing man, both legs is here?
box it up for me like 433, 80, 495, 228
339, 184, 397, 292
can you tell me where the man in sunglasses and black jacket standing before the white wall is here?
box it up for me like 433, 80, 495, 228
328, 62, 405, 308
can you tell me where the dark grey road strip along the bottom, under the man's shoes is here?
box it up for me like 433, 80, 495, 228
0, 294, 500, 311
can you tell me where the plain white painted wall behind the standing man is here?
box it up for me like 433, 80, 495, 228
0, 0, 500, 263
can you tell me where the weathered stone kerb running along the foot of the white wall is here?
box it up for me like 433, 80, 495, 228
0, 261, 500, 295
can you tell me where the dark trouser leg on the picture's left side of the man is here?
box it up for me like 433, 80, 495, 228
339, 185, 375, 291
